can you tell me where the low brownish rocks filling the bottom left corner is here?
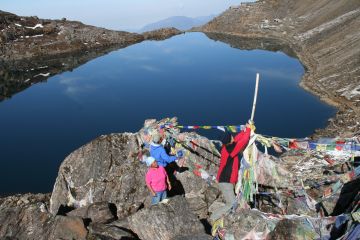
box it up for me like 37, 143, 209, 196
0, 194, 87, 240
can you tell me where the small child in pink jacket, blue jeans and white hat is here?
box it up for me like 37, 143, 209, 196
145, 157, 171, 205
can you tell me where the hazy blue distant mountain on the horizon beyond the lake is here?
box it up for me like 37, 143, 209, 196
139, 15, 216, 32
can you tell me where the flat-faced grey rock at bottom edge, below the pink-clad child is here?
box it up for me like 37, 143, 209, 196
129, 196, 205, 240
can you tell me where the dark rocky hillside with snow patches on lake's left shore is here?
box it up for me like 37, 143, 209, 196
0, 11, 181, 62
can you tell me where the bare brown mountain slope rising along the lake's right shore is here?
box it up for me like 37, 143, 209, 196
198, 0, 360, 136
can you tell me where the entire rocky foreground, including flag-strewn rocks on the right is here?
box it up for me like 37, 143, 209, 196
0, 118, 360, 240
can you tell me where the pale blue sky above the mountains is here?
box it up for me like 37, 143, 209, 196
0, 0, 251, 30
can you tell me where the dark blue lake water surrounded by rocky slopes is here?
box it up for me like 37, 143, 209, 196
0, 33, 335, 195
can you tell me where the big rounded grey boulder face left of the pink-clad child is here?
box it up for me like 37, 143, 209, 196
50, 133, 148, 217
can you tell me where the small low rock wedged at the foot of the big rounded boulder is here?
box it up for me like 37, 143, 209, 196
66, 202, 116, 223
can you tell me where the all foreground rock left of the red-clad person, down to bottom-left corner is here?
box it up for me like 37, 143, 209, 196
0, 119, 219, 239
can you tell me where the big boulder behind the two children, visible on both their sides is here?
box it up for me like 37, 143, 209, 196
50, 119, 218, 221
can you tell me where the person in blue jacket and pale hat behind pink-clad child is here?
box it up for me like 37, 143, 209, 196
150, 134, 178, 167
